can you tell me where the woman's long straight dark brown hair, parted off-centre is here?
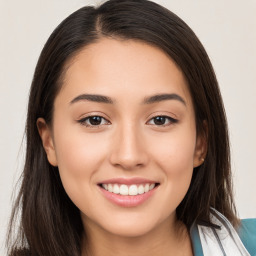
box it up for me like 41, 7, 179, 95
8, 0, 237, 256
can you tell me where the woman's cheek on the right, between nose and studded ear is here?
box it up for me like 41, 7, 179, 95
147, 125, 196, 202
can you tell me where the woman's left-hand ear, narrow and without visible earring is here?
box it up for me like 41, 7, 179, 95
36, 118, 58, 166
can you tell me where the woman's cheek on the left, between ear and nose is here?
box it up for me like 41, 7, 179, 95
52, 125, 108, 207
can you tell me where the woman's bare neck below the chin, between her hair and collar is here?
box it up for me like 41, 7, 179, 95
82, 215, 192, 256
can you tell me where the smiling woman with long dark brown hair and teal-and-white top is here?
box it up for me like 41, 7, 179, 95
6, 0, 256, 256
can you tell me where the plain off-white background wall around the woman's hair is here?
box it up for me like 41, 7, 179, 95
0, 0, 256, 255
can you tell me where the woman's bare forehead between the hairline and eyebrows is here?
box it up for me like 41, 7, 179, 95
56, 38, 191, 107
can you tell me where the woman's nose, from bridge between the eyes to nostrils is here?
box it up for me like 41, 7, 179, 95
110, 123, 149, 170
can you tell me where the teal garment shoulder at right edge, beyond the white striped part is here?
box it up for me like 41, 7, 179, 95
237, 219, 256, 255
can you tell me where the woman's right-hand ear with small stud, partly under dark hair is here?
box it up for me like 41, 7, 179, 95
194, 122, 208, 168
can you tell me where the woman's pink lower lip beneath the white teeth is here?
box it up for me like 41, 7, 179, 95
99, 186, 158, 207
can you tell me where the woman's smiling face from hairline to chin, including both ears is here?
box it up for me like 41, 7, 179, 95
38, 39, 205, 236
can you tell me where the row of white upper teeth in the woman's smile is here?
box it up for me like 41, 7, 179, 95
102, 183, 156, 196
